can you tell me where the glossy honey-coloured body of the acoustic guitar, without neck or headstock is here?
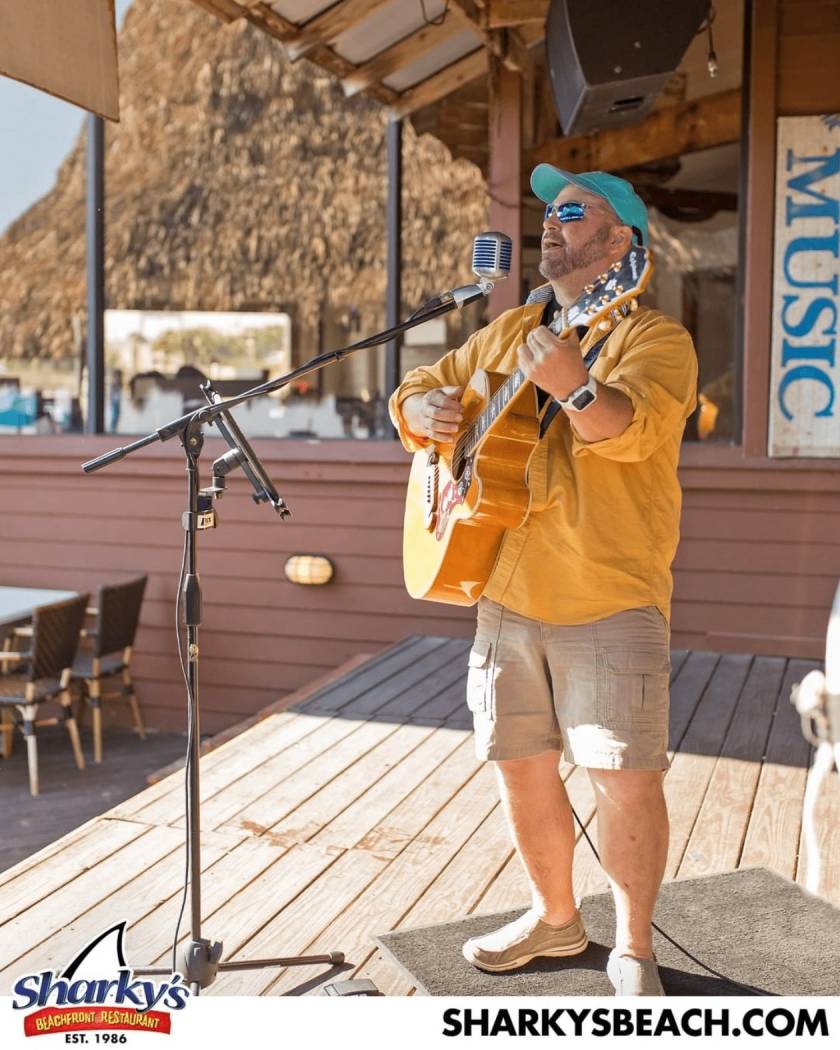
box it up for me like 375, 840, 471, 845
402, 370, 540, 605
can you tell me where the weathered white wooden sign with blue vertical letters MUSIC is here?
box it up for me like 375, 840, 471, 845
769, 113, 840, 457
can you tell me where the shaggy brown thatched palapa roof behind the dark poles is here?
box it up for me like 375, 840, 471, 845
0, 0, 487, 358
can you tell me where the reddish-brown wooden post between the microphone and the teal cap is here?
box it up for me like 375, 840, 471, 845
485, 60, 522, 319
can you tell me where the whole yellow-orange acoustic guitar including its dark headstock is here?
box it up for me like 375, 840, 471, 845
402, 246, 653, 605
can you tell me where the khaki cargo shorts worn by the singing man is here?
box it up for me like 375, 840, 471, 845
466, 597, 671, 770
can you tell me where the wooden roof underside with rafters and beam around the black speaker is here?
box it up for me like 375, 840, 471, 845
188, 0, 742, 185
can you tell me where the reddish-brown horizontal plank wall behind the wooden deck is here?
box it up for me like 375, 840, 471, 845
0, 437, 840, 733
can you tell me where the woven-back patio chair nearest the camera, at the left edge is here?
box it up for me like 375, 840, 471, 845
0, 594, 89, 795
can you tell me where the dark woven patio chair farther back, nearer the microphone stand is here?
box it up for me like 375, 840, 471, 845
72, 576, 147, 762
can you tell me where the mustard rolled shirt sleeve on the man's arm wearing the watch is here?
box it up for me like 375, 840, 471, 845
571, 310, 697, 463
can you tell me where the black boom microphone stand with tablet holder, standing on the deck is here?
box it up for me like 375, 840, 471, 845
82, 277, 494, 995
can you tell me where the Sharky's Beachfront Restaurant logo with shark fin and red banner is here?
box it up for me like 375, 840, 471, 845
12, 920, 190, 1035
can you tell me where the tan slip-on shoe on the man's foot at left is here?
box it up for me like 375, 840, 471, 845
463, 910, 589, 973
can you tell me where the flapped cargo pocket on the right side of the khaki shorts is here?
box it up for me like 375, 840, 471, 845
602, 649, 670, 726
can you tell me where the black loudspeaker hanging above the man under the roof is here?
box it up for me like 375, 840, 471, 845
545, 0, 710, 134
